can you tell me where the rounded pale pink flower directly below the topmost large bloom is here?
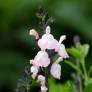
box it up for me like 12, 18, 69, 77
30, 51, 50, 67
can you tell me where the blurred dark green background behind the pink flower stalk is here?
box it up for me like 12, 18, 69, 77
0, 0, 92, 92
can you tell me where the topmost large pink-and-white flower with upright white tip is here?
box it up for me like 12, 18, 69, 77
38, 26, 59, 51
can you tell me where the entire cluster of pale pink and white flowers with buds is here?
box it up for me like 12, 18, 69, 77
30, 26, 69, 92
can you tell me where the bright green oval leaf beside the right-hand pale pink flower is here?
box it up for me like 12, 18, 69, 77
67, 47, 81, 59
